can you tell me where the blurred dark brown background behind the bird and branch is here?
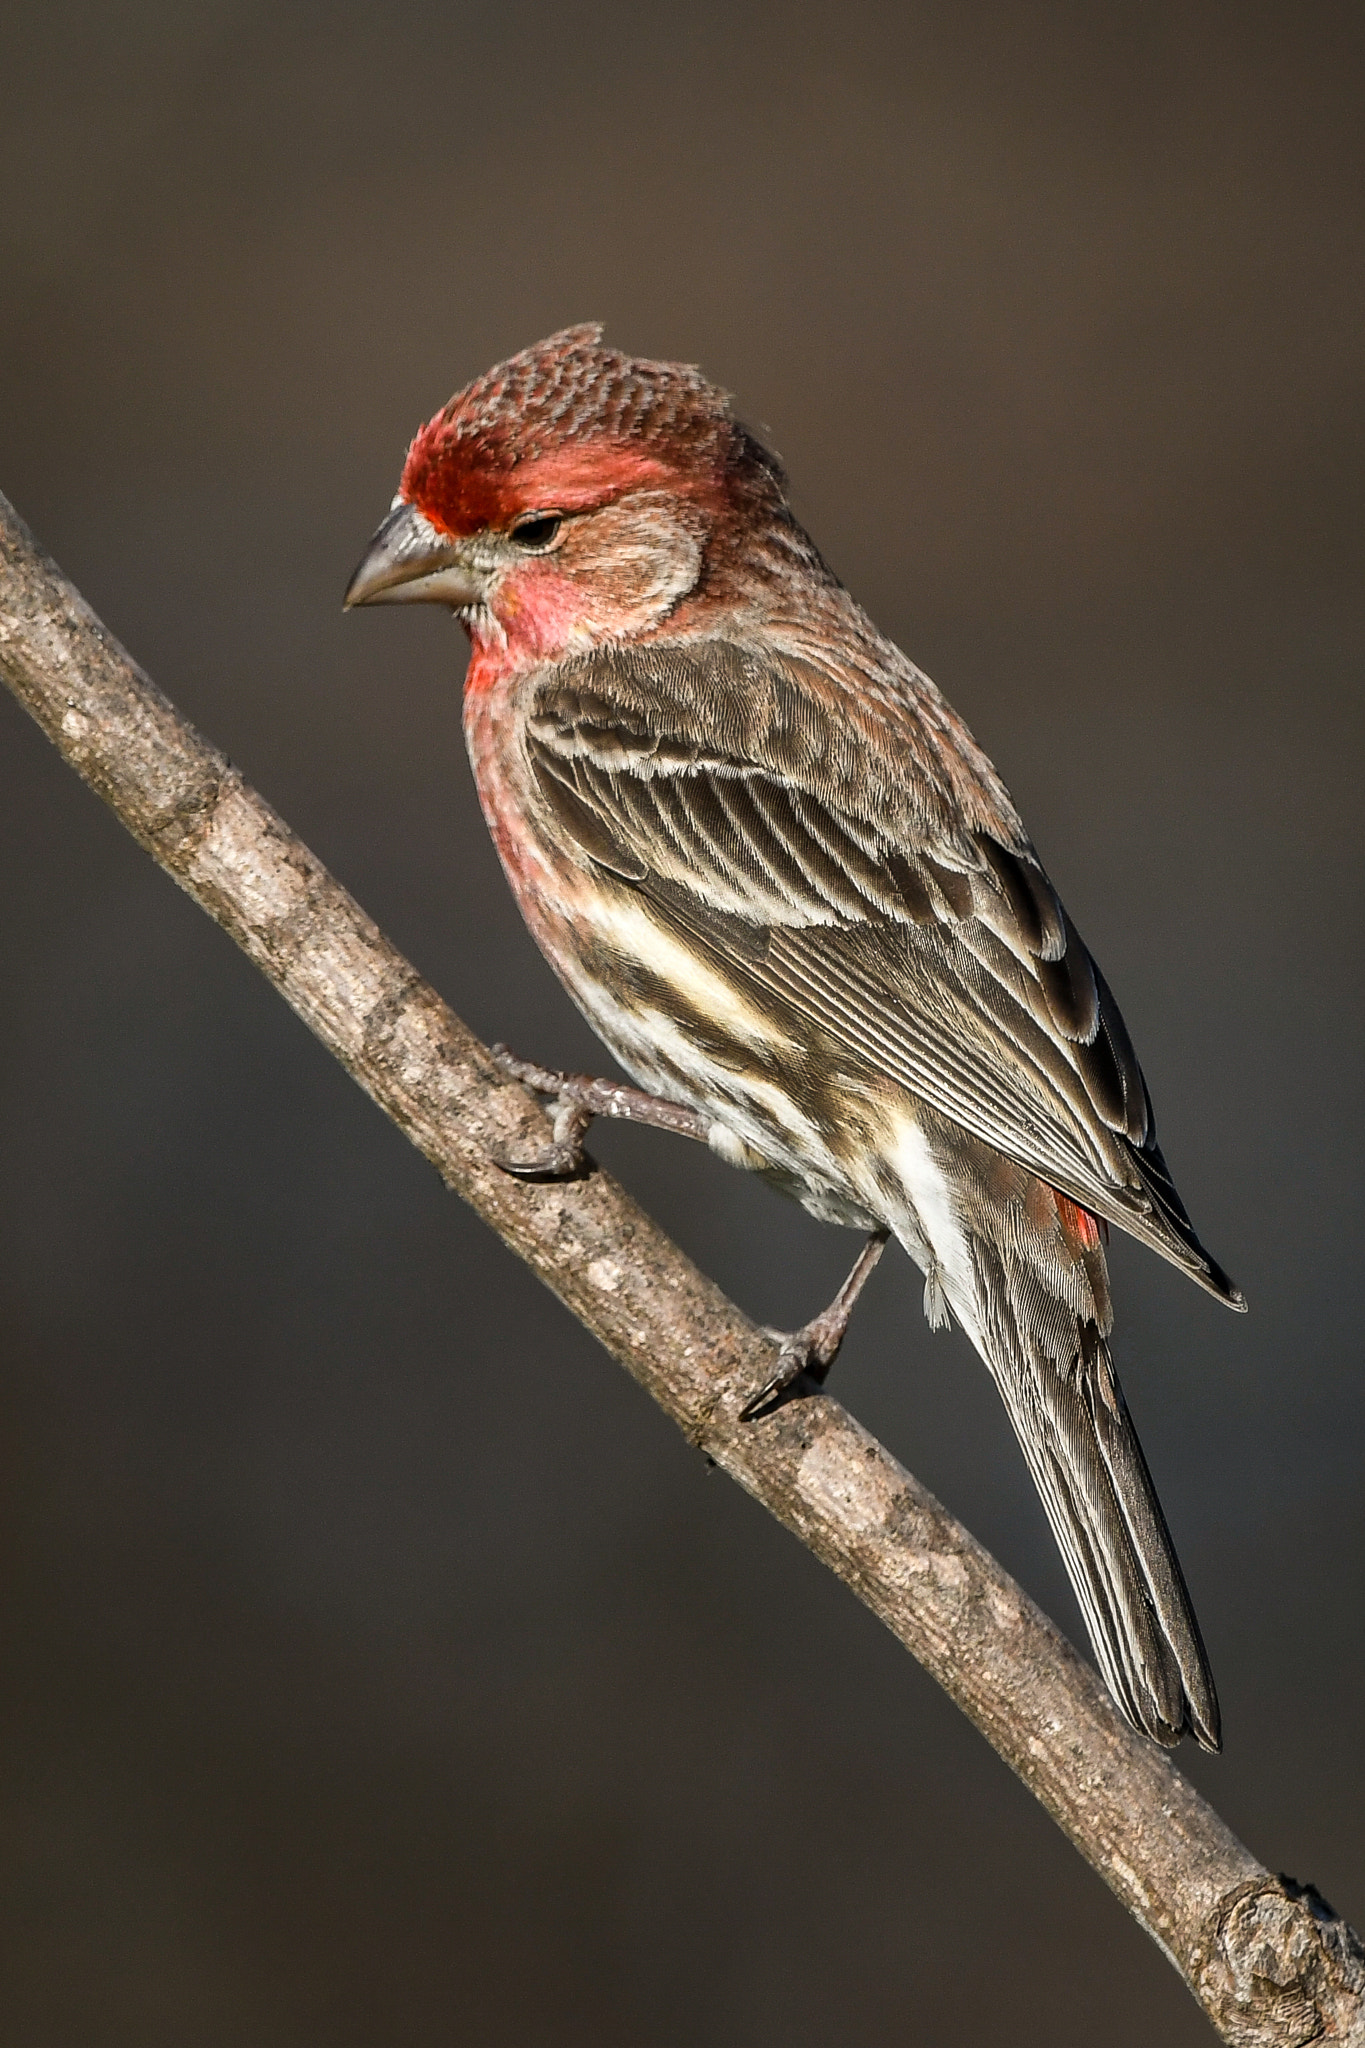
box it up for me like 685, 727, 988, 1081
0, 0, 1365, 2048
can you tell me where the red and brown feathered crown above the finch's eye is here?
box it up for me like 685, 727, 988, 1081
399, 326, 782, 537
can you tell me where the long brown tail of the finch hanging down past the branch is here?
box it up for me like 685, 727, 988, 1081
968, 1219, 1222, 1749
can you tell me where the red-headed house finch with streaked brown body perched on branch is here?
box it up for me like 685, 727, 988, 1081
346, 326, 1242, 1749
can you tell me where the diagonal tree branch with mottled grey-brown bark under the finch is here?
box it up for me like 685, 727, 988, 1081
0, 483, 1365, 2048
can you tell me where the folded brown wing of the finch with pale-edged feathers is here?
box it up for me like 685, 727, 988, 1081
526, 643, 1240, 1300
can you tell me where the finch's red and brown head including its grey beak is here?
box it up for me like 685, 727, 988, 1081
346, 326, 788, 659
